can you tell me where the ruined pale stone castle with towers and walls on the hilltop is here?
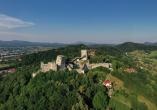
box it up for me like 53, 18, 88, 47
32, 50, 112, 77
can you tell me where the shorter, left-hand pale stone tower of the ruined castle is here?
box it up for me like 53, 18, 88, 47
56, 55, 65, 70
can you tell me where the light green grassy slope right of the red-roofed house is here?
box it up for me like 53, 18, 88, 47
106, 58, 157, 110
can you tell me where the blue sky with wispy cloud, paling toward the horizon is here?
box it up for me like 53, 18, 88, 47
0, 0, 157, 43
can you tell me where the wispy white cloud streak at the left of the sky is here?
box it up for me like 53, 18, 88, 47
0, 14, 34, 29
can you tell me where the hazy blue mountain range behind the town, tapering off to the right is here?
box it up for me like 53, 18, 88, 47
0, 40, 65, 47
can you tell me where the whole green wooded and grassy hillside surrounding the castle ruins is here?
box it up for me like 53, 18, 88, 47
0, 43, 157, 110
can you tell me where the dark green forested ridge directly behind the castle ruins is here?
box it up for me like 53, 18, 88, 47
18, 42, 157, 65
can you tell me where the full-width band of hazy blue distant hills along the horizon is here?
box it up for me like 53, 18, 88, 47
0, 40, 157, 51
